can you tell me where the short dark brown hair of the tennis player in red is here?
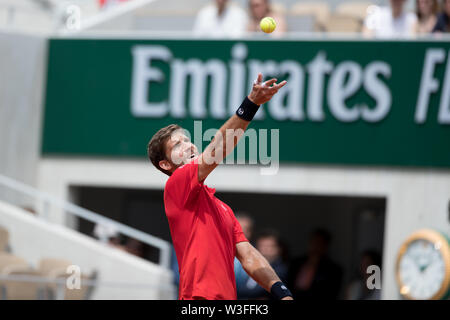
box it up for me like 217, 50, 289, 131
147, 124, 181, 176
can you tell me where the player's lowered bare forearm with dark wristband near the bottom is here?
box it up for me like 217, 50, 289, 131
236, 241, 292, 300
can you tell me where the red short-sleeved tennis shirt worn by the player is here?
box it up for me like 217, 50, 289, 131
164, 159, 248, 300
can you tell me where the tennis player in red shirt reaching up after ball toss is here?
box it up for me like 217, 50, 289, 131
148, 74, 292, 300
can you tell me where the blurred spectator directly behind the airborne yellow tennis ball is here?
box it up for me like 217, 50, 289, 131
247, 0, 287, 37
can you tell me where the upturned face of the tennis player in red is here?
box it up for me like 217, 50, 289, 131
166, 130, 198, 169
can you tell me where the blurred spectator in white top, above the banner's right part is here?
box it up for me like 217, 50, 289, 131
363, 0, 417, 38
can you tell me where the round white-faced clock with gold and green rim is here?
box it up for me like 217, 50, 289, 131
396, 229, 450, 300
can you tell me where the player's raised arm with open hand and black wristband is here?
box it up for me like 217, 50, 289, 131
198, 73, 286, 181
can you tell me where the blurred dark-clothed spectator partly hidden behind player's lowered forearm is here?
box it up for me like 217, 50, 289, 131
237, 230, 287, 300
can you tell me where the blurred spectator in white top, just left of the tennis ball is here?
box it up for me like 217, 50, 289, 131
194, 0, 248, 38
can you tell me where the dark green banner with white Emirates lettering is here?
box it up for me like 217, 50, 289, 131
42, 39, 450, 167
